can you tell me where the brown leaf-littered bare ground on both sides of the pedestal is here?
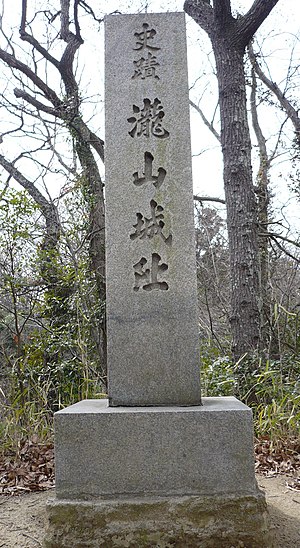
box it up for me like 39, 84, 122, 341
0, 438, 300, 548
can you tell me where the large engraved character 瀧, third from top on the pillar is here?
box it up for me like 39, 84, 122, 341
127, 97, 170, 139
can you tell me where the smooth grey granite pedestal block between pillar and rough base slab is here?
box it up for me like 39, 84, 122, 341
55, 397, 257, 499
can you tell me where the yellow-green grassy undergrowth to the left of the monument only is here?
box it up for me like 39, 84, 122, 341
0, 363, 103, 459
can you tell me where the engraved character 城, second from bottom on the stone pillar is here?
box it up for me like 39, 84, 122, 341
130, 200, 172, 246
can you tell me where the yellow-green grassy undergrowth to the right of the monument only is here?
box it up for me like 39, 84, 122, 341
201, 346, 300, 443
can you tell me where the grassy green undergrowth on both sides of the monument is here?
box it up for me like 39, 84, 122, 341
0, 345, 300, 455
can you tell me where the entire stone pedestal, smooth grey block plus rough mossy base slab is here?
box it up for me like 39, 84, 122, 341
46, 398, 272, 548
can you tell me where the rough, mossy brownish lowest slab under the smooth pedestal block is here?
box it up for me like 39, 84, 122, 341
45, 492, 273, 548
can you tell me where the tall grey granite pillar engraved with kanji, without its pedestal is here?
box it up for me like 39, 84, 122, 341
105, 13, 200, 406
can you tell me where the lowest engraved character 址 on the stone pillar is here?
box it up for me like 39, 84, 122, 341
133, 253, 169, 291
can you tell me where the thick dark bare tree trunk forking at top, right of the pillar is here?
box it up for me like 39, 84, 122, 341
184, 0, 278, 360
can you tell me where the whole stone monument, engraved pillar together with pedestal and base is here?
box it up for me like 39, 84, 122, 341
46, 13, 271, 548
